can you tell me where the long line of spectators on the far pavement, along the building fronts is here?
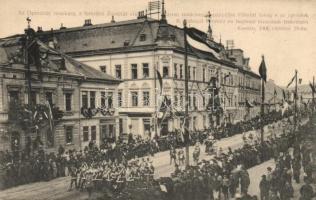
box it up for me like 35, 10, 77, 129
0, 113, 290, 191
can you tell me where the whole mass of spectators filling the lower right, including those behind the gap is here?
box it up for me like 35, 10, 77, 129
160, 115, 316, 200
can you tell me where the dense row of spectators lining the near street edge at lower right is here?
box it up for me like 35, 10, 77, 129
160, 119, 291, 200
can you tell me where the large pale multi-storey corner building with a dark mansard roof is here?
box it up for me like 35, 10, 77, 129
32, 10, 260, 136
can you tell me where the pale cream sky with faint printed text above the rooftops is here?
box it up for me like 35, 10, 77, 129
0, 0, 316, 86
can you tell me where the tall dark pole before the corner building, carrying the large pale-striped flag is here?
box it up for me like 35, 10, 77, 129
183, 20, 190, 166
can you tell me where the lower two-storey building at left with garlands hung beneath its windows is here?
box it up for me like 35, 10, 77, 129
0, 32, 120, 150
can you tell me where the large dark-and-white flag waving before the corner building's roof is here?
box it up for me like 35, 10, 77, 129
186, 28, 220, 59
